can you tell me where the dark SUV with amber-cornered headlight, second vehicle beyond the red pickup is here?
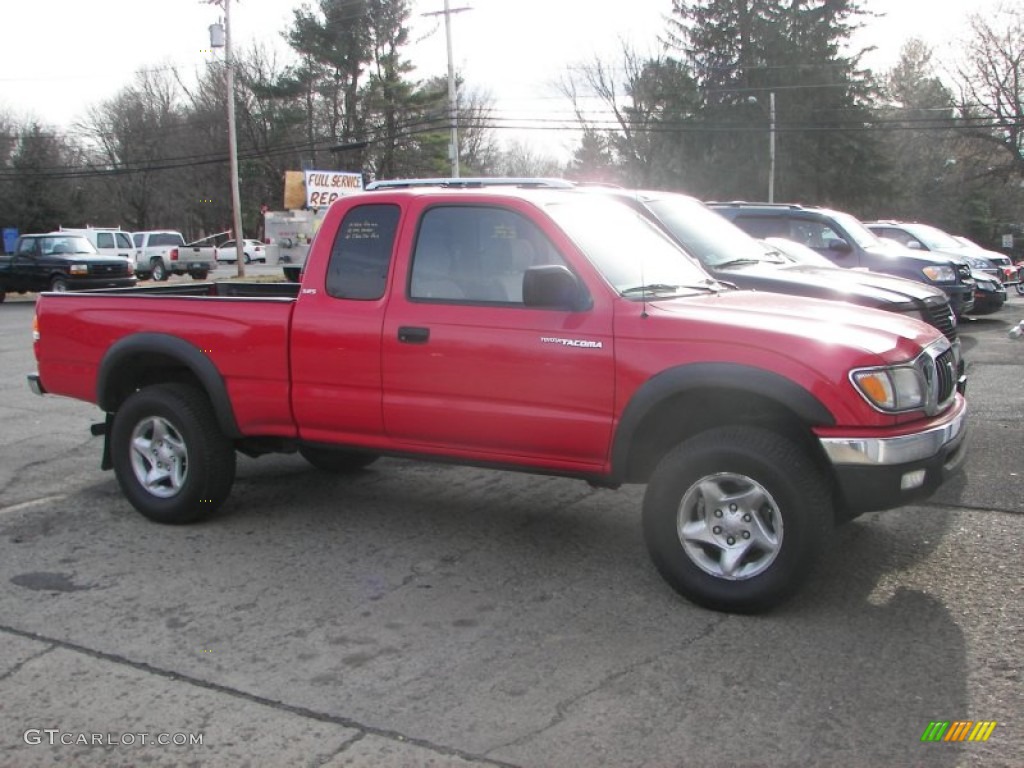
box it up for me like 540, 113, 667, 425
708, 203, 975, 316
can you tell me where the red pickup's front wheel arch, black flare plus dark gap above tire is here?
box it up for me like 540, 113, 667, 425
611, 362, 835, 482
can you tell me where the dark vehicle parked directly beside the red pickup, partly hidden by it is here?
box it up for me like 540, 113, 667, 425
588, 187, 961, 354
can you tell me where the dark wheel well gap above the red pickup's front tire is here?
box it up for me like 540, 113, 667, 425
624, 388, 831, 483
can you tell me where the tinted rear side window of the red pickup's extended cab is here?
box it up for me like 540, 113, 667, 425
327, 205, 398, 301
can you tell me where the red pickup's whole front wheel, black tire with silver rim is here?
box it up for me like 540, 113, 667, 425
643, 426, 834, 613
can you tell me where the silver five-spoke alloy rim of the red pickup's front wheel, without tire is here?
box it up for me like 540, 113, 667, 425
676, 472, 782, 581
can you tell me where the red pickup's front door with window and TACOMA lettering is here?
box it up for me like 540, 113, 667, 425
382, 203, 614, 471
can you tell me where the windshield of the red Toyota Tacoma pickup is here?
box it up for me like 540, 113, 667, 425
547, 197, 717, 299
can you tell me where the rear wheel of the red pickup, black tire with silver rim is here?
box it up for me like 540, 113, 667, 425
111, 384, 234, 525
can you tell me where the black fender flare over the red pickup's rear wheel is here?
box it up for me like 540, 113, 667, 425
96, 333, 242, 438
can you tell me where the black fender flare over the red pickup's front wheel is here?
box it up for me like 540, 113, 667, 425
611, 362, 836, 482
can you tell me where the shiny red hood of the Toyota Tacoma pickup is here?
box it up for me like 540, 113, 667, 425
646, 291, 943, 360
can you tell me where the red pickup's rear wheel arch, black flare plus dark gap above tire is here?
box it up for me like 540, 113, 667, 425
96, 333, 242, 439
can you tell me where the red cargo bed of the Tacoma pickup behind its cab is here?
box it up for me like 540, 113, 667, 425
36, 283, 299, 436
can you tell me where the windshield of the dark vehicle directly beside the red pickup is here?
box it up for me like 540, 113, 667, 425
643, 195, 777, 267
